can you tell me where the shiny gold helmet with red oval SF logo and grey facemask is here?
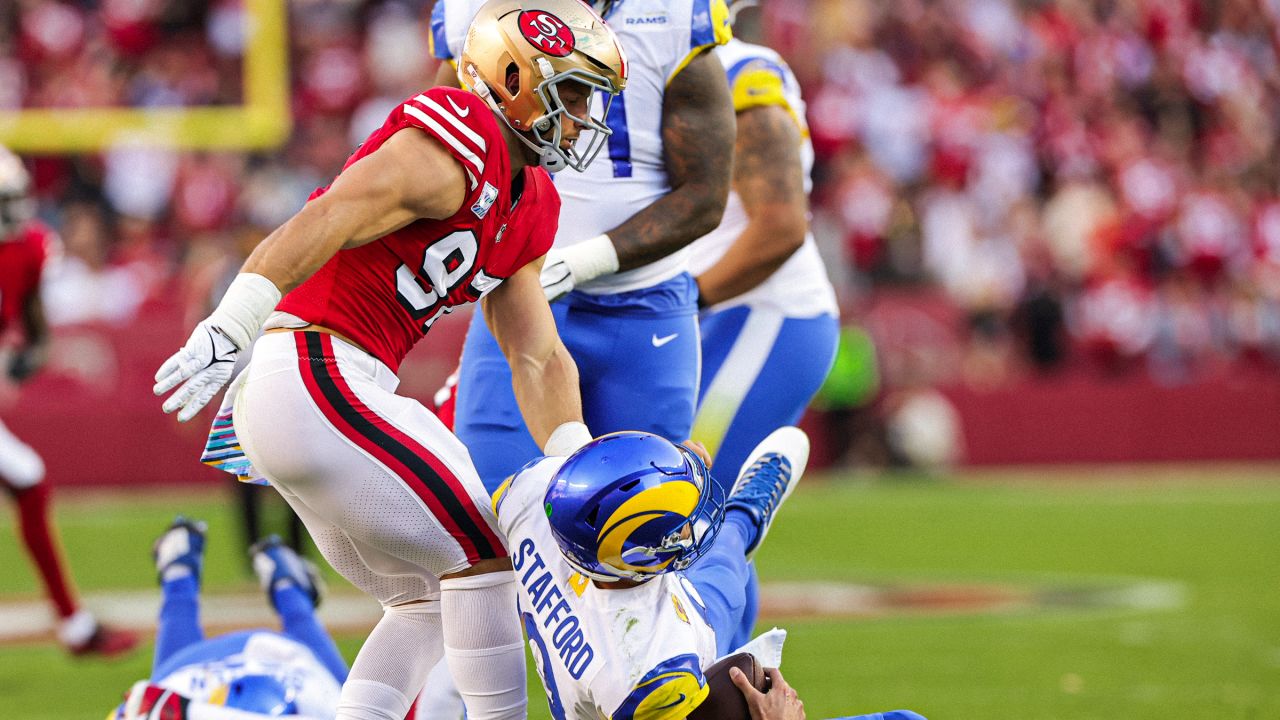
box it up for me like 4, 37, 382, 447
458, 0, 627, 173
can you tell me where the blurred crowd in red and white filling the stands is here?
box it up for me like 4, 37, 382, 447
0, 0, 1280, 383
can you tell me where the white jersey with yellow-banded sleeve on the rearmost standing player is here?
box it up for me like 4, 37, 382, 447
689, 40, 838, 318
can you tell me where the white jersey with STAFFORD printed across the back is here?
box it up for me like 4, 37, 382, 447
494, 457, 716, 720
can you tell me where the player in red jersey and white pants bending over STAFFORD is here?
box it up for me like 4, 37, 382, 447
155, 0, 626, 720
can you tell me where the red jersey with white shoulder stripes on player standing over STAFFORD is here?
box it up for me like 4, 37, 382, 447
278, 87, 559, 370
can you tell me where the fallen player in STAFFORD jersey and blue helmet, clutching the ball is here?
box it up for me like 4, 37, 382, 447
460, 428, 918, 720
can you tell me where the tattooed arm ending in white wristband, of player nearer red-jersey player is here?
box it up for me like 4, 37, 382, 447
608, 51, 736, 270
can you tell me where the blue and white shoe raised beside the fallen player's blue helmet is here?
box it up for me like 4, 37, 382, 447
724, 425, 809, 560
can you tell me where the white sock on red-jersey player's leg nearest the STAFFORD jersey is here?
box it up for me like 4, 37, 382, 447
440, 570, 529, 720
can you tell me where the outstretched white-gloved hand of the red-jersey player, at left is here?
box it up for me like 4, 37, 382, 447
151, 319, 241, 423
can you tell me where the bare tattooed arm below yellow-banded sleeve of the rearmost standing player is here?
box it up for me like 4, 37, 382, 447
698, 105, 809, 305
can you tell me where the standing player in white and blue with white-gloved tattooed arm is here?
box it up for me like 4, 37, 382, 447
431, 0, 735, 491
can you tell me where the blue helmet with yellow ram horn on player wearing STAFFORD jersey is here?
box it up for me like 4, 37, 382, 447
544, 432, 724, 582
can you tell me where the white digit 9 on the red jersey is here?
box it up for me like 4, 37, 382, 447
396, 231, 480, 332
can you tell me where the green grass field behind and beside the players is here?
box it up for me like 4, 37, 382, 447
0, 468, 1280, 720
